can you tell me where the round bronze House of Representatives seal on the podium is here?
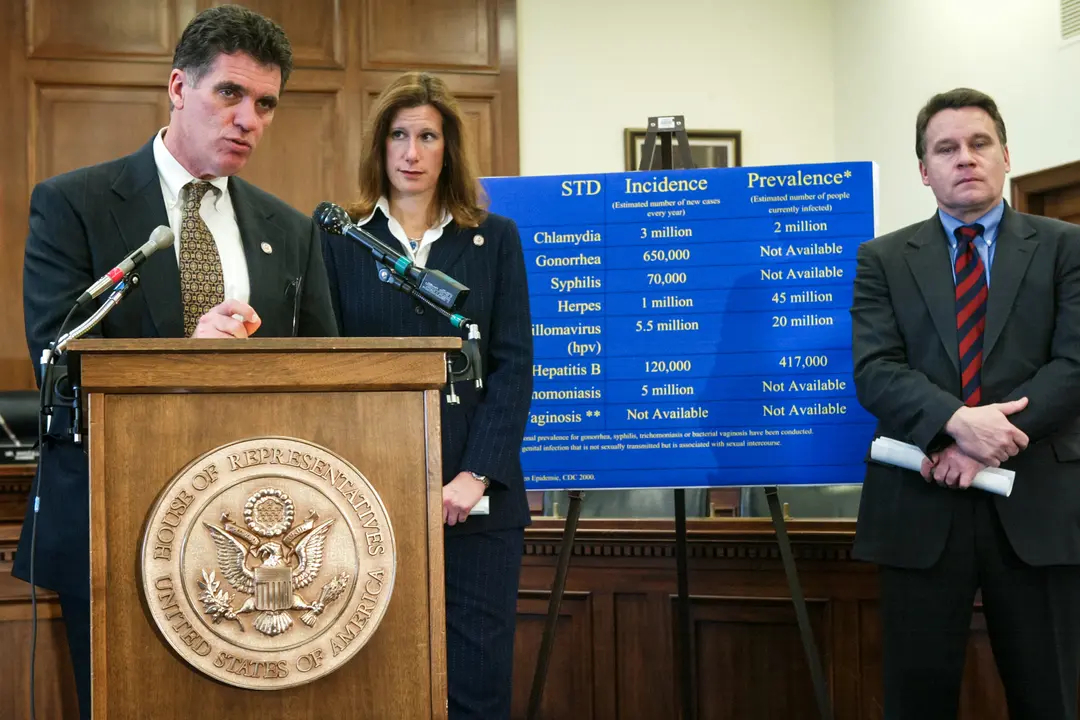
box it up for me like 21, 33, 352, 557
139, 437, 396, 690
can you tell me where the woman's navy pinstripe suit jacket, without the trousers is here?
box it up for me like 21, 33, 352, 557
323, 212, 532, 533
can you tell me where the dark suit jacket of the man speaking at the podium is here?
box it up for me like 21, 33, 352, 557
13, 134, 337, 597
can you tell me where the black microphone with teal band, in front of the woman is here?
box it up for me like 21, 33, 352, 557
312, 202, 469, 313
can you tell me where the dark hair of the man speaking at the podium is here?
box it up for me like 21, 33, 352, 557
173, 5, 293, 90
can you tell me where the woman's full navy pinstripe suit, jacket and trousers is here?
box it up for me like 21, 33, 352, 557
323, 205, 532, 720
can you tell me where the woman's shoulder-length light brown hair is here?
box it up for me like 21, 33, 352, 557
349, 72, 487, 228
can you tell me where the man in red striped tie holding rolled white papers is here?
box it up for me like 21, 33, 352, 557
851, 89, 1080, 720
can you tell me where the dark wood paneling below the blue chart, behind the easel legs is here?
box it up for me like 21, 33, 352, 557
513, 518, 1028, 720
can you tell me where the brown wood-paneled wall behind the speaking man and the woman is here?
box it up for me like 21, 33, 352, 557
0, 0, 518, 390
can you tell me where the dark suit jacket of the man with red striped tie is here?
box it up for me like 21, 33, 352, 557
851, 206, 1080, 568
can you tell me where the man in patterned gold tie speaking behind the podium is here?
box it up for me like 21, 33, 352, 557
13, 5, 337, 718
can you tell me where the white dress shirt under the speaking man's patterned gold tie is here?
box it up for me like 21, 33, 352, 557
153, 127, 252, 303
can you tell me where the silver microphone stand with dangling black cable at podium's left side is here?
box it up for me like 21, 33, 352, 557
30, 273, 139, 720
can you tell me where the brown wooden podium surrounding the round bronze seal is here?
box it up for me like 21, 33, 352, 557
70, 338, 460, 720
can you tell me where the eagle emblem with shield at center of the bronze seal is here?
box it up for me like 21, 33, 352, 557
199, 488, 349, 637
